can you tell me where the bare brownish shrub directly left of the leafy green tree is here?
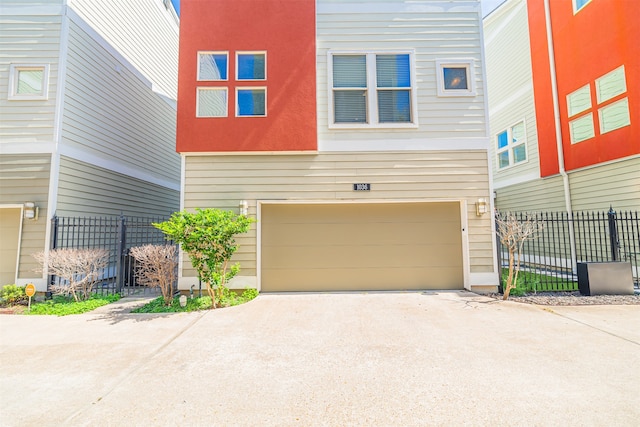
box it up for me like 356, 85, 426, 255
130, 245, 178, 305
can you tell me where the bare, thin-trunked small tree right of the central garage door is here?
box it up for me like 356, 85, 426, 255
496, 213, 543, 300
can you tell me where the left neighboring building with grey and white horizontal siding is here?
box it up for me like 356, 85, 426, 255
0, 0, 180, 291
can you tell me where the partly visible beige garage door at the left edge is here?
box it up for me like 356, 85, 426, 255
0, 208, 21, 286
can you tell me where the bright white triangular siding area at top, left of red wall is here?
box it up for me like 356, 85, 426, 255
68, 0, 178, 100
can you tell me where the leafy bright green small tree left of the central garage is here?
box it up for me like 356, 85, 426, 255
153, 209, 254, 308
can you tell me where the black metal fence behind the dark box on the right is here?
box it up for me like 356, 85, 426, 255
498, 209, 640, 291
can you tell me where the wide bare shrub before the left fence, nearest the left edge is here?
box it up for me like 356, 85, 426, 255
33, 249, 109, 301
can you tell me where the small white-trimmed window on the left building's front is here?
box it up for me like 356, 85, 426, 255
8, 64, 49, 101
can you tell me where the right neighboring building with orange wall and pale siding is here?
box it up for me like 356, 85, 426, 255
483, 0, 640, 212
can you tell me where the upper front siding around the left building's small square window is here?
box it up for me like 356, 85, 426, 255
0, 10, 61, 152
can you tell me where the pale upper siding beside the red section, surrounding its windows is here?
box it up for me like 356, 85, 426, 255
317, 0, 487, 146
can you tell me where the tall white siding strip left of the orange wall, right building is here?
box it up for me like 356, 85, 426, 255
484, 0, 540, 188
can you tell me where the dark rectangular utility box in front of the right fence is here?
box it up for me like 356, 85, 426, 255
578, 262, 633, 295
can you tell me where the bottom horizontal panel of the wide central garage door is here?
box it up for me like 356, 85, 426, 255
262, 267, 461, 292
